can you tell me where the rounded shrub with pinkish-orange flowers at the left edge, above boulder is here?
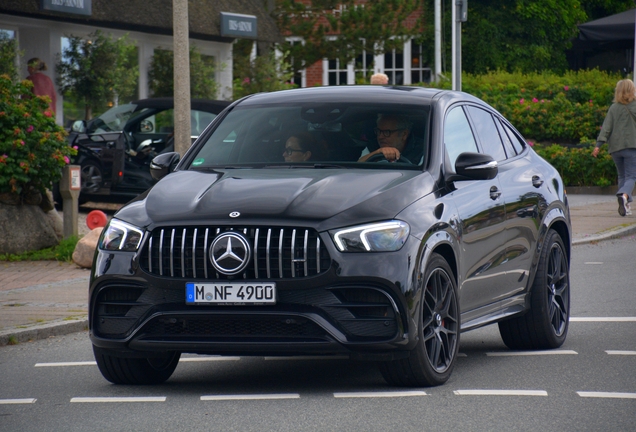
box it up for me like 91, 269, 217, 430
0, 75, 77, 197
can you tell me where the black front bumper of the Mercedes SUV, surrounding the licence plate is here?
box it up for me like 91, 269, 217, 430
89, 238, 419, 360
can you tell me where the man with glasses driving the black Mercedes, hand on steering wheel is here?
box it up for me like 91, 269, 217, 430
358, 114, 422, 164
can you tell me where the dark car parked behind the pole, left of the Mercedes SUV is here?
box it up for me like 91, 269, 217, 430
55, 98, 230, 202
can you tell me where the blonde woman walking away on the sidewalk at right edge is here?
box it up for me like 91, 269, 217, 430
592, 79, 636, 216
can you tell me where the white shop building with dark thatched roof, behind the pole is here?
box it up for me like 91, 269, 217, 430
0, 0, 280, 124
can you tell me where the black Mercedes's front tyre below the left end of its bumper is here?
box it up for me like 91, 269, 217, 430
93, 346, 181, 384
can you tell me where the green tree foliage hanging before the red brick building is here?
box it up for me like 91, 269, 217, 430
272, 0, 422, 65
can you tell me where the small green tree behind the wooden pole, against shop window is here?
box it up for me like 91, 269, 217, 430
148, 46, 219, 99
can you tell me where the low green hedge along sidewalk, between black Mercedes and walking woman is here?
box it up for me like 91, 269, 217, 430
533, 144, 617, 187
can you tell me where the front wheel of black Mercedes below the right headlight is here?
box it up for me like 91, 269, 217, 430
380, 253, 460, 387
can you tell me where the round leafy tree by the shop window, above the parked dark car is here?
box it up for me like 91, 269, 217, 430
55, 30, 139, 120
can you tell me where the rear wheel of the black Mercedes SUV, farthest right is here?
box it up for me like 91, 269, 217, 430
499, 230, 570, 350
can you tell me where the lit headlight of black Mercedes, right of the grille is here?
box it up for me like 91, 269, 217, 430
331, 220, 410, 252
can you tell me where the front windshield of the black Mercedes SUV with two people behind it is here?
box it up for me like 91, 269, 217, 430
190, 103, 429, 169
